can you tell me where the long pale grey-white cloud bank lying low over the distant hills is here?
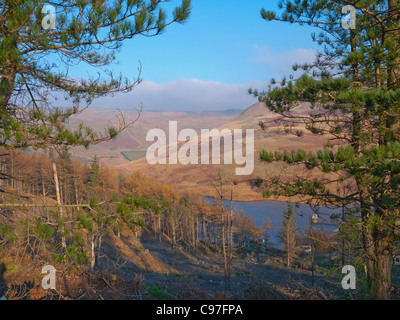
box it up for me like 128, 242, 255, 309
93, 79, 266, 111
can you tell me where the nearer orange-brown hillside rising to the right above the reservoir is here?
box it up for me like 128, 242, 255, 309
117, 102, 326, 201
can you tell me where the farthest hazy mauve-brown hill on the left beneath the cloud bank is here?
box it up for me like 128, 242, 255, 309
70, 108, 243, 166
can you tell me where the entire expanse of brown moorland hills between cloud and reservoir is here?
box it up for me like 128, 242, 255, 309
72, 102, 329, 201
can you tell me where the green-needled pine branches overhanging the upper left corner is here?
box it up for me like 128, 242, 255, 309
0, 0, 191, 149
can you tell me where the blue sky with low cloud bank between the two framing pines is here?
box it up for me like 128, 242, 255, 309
83, 0, 318, 110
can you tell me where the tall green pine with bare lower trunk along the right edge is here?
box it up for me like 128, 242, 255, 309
250, 0, 400, 299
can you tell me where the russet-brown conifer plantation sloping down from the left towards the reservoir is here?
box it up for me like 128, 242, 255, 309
0, 149, 267, 300
